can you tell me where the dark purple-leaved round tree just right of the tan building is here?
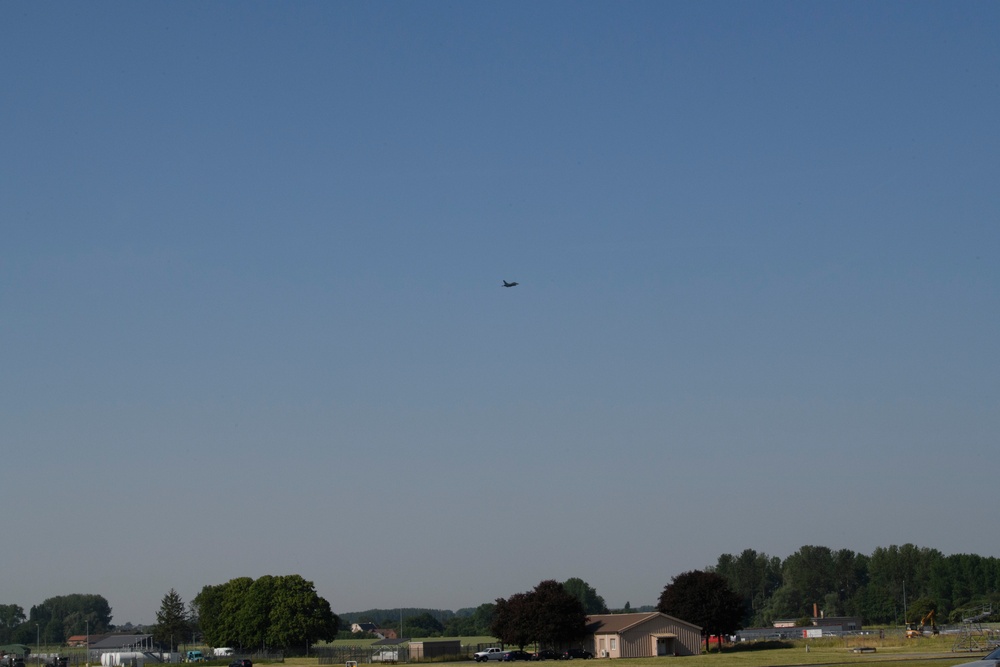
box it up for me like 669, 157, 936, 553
656, 570, 743, 651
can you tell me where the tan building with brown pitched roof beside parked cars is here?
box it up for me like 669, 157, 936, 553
587, 611, 701, 658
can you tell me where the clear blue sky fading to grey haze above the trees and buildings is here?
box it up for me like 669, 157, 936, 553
0, 1, 1000, 623
